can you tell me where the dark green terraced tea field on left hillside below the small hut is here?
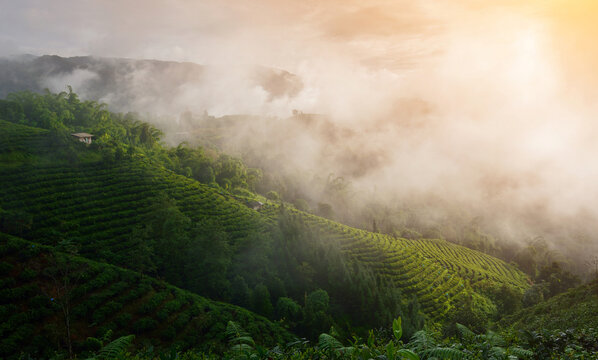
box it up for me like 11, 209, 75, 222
0, 161, 264, 265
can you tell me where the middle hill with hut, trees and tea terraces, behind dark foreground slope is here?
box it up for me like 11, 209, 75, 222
0, 92, 529, 354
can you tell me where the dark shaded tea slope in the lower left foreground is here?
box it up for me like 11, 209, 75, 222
0, 234, 292, 358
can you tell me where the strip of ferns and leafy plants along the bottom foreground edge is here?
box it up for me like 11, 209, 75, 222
21, 318, 598, 360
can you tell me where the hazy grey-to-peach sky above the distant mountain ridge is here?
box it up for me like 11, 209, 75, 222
0, 0, 544, 69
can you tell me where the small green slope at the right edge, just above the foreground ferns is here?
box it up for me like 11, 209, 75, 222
500, 281, 598, 331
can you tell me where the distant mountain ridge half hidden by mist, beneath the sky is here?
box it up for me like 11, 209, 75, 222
0, 55, 303, 112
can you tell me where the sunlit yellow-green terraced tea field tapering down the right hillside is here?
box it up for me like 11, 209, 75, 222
263, 210, 529, 319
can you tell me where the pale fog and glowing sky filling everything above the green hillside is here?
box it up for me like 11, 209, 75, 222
0, 0, 598, 272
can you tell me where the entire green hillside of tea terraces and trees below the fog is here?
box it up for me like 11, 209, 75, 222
0, 88, 598, 359
